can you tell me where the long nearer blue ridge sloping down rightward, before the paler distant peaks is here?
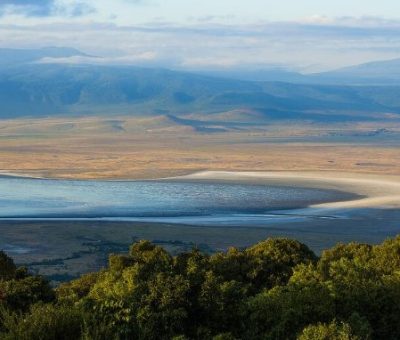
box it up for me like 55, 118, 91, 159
0, 64, 400, 120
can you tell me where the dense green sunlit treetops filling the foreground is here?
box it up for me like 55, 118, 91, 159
0, 237, 400, 340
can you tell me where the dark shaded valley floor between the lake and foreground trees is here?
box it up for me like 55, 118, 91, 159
0, 209, 400, 282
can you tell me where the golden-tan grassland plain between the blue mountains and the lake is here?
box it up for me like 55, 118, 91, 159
0, 112, 400, 179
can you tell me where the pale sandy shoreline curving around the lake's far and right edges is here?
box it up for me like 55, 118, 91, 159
0, 171, 400, 210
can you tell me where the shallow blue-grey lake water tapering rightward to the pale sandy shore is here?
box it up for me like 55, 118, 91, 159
0, 177, 354, 223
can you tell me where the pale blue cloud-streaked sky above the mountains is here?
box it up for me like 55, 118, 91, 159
0, 0, 400, 73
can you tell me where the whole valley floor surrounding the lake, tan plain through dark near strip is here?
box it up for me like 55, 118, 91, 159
0, 117, 400, 281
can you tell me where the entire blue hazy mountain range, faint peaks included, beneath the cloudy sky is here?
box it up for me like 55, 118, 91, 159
0, 47, 400, 122
